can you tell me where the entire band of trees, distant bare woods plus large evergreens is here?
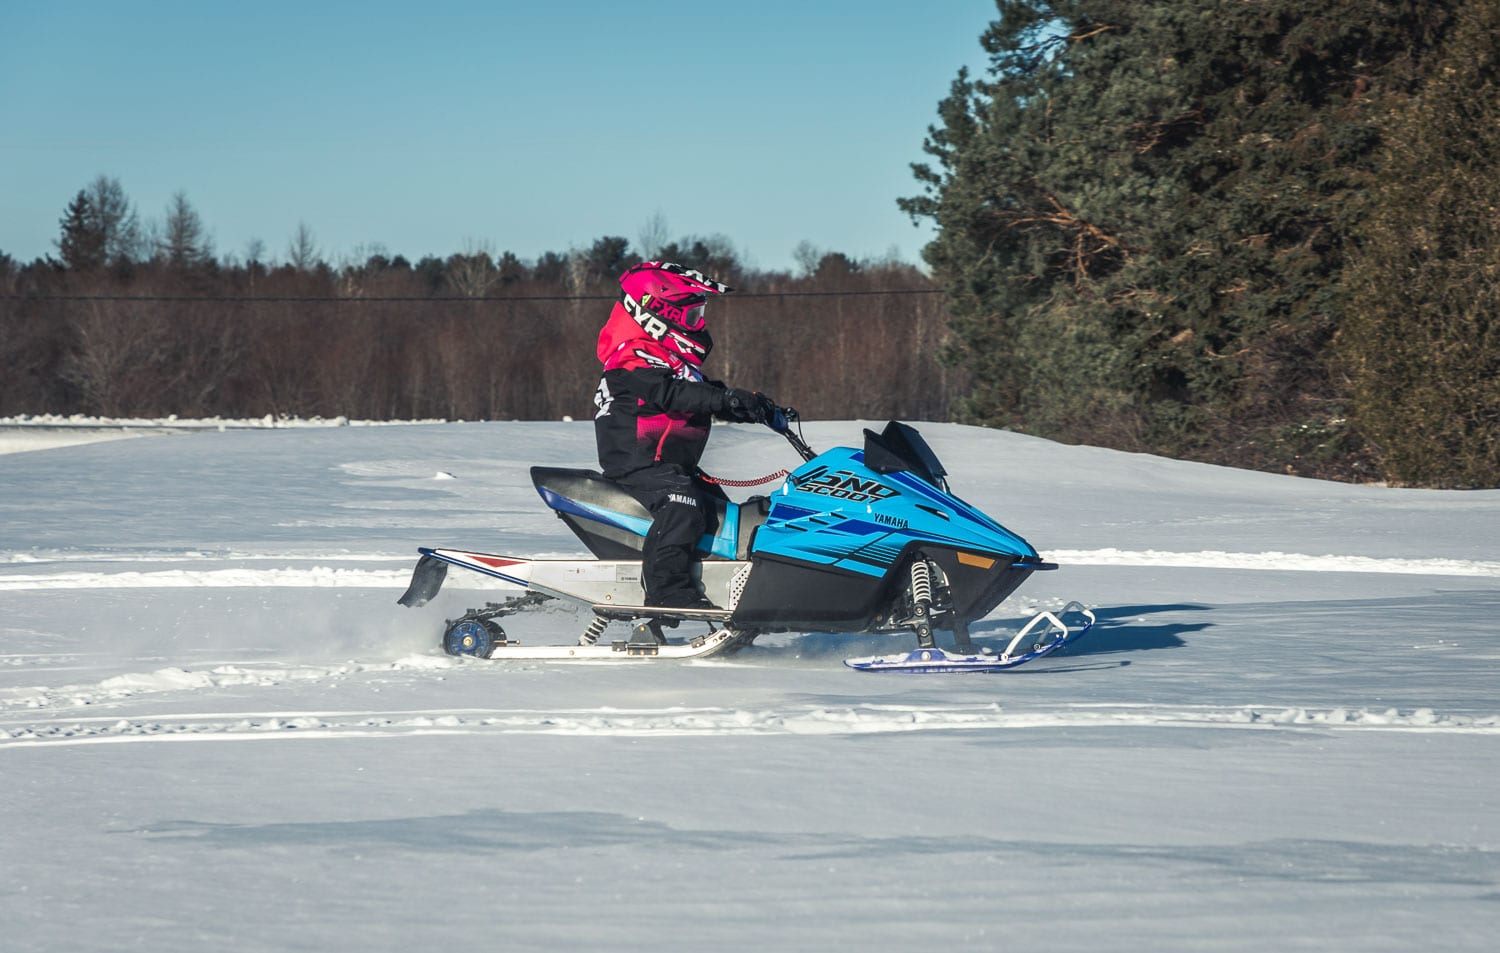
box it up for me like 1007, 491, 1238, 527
0, 0, 1500, 488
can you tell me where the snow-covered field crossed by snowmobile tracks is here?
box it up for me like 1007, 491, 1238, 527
0, 422, 1500, 953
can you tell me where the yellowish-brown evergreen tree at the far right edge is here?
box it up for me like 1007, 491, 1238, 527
1340, 0, 1500, 486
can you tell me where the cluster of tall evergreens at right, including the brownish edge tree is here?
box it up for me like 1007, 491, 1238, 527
902, 0, 1500, 486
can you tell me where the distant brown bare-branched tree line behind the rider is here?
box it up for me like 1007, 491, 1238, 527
0, 189, 960, 420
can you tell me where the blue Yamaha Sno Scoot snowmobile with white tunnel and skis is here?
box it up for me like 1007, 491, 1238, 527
399, 408, 1094, 672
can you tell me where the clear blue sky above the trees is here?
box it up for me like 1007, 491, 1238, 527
0, 0, 995, 269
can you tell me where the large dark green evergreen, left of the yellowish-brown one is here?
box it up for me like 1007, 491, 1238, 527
902, 0, 1452, 471
